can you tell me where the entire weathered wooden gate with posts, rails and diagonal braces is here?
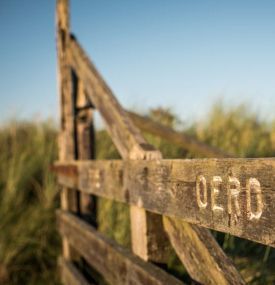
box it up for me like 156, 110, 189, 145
55, 0, 275, 285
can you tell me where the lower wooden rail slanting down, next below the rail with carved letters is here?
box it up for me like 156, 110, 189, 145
58, 211, 183, 285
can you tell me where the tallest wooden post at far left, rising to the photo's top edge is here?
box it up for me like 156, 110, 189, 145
56, 0, 78, 259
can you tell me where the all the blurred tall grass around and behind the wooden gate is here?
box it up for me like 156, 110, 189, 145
0, 104, 275, 284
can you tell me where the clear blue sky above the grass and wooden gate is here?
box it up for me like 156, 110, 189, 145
0, 0, 275, 123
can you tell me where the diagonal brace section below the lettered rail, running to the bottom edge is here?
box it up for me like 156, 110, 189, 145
163, 217, 245, 285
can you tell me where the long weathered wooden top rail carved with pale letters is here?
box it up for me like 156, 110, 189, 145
55, 158, 275, 247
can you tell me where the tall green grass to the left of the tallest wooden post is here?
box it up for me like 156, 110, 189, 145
0, 120, 59, 284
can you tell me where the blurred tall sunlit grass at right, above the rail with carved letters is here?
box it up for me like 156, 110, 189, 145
194, 103, 275, 157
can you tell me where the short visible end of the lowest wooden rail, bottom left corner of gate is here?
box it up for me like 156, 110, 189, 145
58, 258, 92, 285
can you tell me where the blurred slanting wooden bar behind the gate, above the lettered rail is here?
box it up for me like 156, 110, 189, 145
127, 112, 233, 157
